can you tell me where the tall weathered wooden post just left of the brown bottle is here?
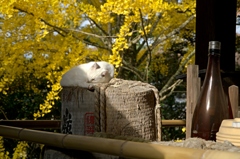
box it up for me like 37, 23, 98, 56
186, 65, 201, 139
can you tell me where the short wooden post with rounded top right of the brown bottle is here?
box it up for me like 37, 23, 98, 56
228, 85, 238, 118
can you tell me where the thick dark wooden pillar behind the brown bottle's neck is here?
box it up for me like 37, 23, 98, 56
195, 0, 237, 71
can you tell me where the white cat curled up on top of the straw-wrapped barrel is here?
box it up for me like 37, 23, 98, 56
60, 61, 114, 89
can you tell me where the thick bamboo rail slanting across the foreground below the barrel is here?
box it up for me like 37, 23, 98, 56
0, 126, 239, 159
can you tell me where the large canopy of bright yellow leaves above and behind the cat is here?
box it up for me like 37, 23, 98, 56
0, 0, 195, 119
